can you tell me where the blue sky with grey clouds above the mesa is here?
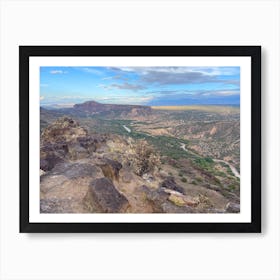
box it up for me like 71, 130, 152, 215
40, 66, 240, 107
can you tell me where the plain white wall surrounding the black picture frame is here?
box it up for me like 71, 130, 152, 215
0, 0, 280, 280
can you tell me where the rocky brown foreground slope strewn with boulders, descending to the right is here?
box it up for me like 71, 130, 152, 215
40, 116, 234, 213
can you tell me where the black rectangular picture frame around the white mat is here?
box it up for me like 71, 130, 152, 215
19, 46, 261, 233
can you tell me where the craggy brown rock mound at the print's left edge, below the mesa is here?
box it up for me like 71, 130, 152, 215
41, 117, 88, 143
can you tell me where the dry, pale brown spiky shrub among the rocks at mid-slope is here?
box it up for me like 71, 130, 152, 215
132, 140, 161, 176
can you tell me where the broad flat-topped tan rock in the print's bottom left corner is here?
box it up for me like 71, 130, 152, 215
40, 162, 104, 213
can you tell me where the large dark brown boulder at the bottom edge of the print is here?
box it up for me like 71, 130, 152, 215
85, 178, 129, 213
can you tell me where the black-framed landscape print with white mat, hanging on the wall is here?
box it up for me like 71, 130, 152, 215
19, 46, 261, 233
